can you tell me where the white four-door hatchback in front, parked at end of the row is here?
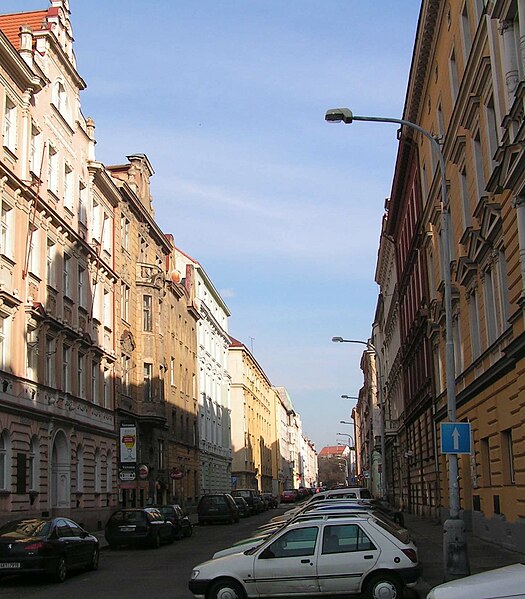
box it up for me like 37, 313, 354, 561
189, 515, 421, 599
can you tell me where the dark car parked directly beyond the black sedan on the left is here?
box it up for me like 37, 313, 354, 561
104, 507, 175, 549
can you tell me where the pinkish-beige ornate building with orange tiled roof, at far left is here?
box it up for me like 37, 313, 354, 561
0, 1, 117, 526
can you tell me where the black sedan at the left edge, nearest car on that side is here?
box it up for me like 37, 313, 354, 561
0, 518, 99, 582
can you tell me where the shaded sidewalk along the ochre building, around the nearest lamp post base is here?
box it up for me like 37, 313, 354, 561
404, 513, 523, 599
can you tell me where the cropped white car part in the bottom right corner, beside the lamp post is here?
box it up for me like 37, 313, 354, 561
427, 562, 525, 599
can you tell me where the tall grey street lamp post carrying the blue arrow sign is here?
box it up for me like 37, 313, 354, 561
325, 108, 470, 580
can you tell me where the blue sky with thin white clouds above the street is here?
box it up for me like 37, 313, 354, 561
6, 0, 420, 450
